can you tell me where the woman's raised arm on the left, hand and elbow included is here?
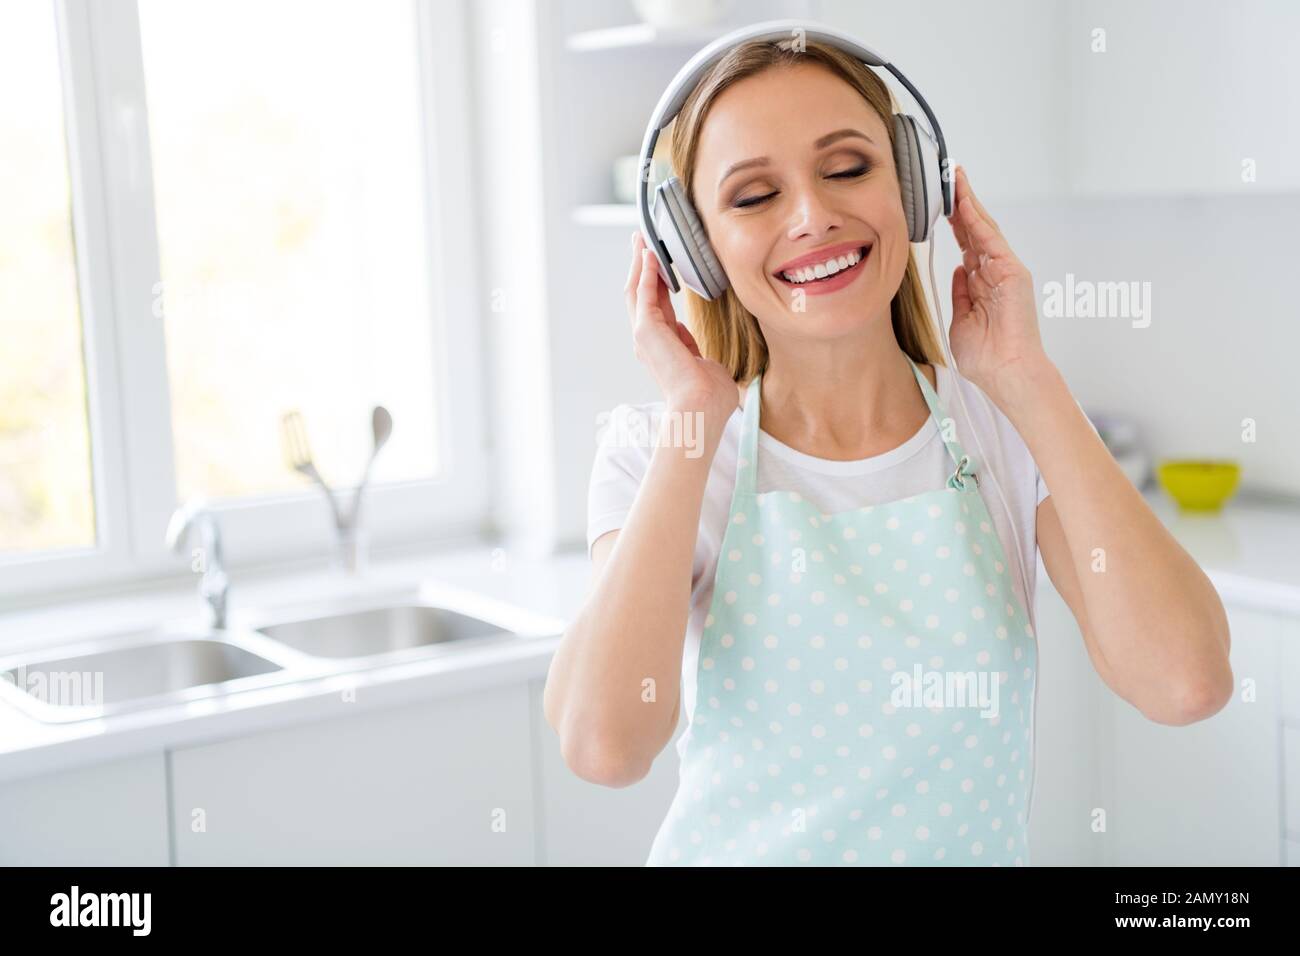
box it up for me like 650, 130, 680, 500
542, 234, 740, 787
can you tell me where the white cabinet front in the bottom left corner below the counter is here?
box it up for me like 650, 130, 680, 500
0, 752, 168, 866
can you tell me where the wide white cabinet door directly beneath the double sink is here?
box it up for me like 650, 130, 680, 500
172, 684, 536, 865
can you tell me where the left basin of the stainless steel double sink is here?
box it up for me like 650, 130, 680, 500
0, 628, 296, 723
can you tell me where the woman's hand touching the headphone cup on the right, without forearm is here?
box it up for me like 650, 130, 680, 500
948, 166, 1047, 405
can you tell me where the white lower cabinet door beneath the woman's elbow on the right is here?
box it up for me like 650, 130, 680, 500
1106, 607, 1282, 866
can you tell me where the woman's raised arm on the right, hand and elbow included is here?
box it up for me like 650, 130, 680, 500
949, 169, 1232, 724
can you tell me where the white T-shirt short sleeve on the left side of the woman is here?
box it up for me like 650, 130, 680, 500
586, 405, 654, 558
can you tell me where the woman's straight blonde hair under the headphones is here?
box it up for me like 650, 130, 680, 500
671, 40, 945, 382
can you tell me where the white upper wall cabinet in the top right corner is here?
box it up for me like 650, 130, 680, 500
1066, 0, 1300, 195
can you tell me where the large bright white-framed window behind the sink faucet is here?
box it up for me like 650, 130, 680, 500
0, 0, 486, 602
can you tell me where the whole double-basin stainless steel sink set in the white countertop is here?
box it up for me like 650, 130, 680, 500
0, 587, 563, 723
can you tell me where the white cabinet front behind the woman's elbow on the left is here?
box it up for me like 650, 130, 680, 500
533, 680, 686, 866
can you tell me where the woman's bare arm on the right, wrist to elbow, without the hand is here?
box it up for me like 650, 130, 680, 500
1009, 365, 1232, 724
